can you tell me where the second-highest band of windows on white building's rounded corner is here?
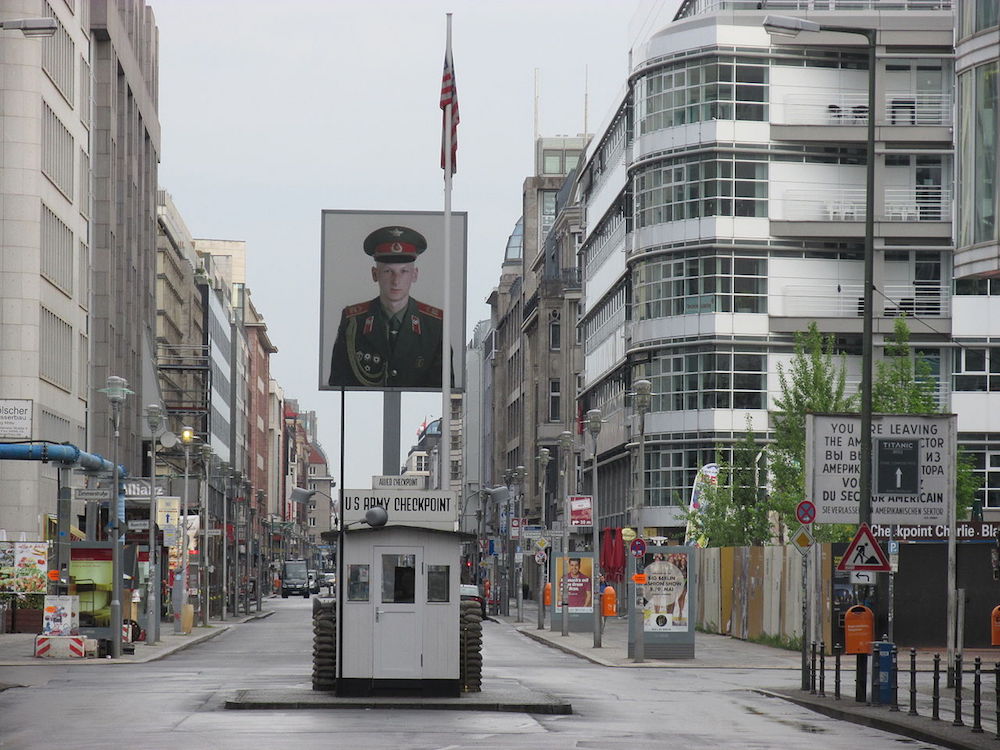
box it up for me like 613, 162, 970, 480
636, 153, 768, 227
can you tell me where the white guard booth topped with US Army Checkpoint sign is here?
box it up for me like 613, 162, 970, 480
337, 490, 467, 696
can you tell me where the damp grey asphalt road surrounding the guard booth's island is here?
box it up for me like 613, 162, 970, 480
0, 598, 933, 750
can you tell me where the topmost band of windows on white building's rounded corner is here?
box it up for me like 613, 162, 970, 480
638, 56, 768, 134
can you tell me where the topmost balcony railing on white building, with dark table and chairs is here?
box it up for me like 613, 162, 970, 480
775, 91, 952, 127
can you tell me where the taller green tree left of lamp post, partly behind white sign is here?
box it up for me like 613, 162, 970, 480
769, 322, 857, 541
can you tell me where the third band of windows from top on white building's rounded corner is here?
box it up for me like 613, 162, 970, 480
633, 256, 767, 320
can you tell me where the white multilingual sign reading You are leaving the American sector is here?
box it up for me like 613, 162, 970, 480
806, 414, 956, 524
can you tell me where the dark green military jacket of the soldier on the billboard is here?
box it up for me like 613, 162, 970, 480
329, 297, 444, 388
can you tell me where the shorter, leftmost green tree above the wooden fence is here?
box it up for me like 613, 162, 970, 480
686, 419, 771, 547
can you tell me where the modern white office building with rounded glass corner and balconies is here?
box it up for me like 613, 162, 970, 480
579, 0, 980, 539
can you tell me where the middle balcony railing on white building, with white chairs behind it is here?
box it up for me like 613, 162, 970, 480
771, 185, 952, 221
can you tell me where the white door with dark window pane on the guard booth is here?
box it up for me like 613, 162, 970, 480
372, 547, 426, 679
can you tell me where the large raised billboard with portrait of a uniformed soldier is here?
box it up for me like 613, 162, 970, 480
319, 211, 467, 391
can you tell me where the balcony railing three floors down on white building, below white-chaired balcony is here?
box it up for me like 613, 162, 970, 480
783, 282, 951, 318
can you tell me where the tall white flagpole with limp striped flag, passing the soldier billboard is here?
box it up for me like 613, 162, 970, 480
439, 13, 455, 496
